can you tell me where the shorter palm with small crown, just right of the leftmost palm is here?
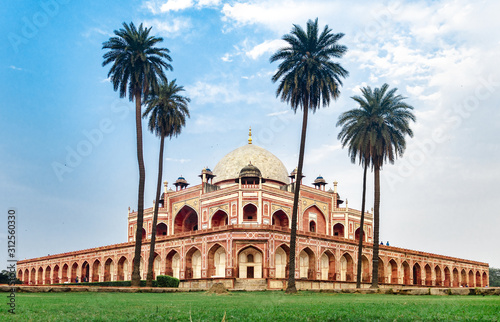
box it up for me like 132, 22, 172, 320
142, 79, 191, 287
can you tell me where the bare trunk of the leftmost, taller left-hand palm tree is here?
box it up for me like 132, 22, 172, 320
132, 92, 146, 287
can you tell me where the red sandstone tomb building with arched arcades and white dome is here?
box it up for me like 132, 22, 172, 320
17, 131, 489, 289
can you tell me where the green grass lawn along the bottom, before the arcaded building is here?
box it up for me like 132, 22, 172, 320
0, 292, 500, 321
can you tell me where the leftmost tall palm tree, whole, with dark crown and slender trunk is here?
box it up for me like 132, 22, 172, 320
102, 22, 172, 286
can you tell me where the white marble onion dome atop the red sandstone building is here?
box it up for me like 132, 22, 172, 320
213, 144, 290, 184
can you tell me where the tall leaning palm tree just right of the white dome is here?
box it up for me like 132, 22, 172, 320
270, 18, 349, 293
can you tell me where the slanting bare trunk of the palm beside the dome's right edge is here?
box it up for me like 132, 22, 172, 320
286, 102, 309, 293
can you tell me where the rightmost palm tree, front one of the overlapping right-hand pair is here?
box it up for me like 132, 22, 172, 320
352, 84, 416, 288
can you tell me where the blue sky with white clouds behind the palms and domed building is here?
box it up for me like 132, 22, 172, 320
0, 0, 500, 267
